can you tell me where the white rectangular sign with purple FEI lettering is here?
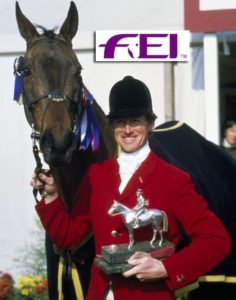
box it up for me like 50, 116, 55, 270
96, 30, 190, 62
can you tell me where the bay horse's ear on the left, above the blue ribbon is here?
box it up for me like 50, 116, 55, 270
16, 1, 39, 43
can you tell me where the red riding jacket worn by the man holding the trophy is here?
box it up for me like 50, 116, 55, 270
36, 152, 230, 300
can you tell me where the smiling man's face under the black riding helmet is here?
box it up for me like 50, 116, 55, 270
112, 117, 153, 153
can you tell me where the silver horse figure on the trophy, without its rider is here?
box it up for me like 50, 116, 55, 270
108, 201, 168, 250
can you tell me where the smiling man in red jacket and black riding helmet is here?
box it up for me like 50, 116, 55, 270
32, 76, 230, 300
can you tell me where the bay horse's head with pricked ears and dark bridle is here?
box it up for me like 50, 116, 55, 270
16, 2, 82, 165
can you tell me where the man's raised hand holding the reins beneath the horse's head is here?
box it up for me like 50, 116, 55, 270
30, 173, 58, 204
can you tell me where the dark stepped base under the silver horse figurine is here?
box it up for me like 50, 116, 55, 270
94, 241, 174, 274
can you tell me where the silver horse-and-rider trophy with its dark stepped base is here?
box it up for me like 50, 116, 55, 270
95, 189, 174, 274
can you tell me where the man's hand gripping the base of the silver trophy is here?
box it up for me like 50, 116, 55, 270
123, 252, 167, 281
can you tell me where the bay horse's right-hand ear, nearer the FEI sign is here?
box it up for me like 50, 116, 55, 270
60, 1, 79, 42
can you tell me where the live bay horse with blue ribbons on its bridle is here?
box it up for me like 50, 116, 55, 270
15, 2, 116, 300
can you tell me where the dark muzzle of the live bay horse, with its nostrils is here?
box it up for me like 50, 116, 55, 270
39, 131, 77, 166
